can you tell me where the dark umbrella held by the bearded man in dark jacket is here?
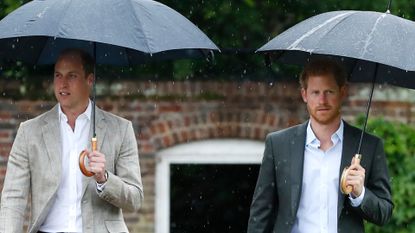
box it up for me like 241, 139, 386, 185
257, 5, 415, 193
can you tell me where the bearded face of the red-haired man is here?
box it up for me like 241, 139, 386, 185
301, 75, 347, 125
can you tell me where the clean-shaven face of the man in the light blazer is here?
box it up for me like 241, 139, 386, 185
53, 53, 94, 114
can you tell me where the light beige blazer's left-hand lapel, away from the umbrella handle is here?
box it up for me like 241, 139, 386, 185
42, 105, 62, 176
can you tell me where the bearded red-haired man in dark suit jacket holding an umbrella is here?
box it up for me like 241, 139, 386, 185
248, 60, 393, 233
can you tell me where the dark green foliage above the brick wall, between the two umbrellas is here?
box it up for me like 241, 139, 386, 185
0, 0, 415, 82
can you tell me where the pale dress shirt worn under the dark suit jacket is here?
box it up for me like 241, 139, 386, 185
292, 121, 344, 233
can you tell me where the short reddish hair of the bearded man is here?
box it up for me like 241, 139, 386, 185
300, 58, 347, 89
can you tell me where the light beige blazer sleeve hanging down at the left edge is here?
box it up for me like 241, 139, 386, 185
0, 123, 30, 233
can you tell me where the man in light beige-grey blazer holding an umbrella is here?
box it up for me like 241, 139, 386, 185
0, 49, 143, 233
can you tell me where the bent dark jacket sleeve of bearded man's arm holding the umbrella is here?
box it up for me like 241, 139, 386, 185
355, 140, 393, 225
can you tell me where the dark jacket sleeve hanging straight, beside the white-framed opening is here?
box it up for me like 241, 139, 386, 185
247, 135, 278, 233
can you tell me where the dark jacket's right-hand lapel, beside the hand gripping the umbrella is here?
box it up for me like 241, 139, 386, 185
337, 121, 359, 217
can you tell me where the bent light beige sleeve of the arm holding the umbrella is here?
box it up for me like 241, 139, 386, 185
98, 122, 144, 211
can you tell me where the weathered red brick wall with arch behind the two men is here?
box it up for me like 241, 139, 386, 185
0, 81, 415, 233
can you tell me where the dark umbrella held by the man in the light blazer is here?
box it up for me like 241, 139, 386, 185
0, 0, 219, 176
